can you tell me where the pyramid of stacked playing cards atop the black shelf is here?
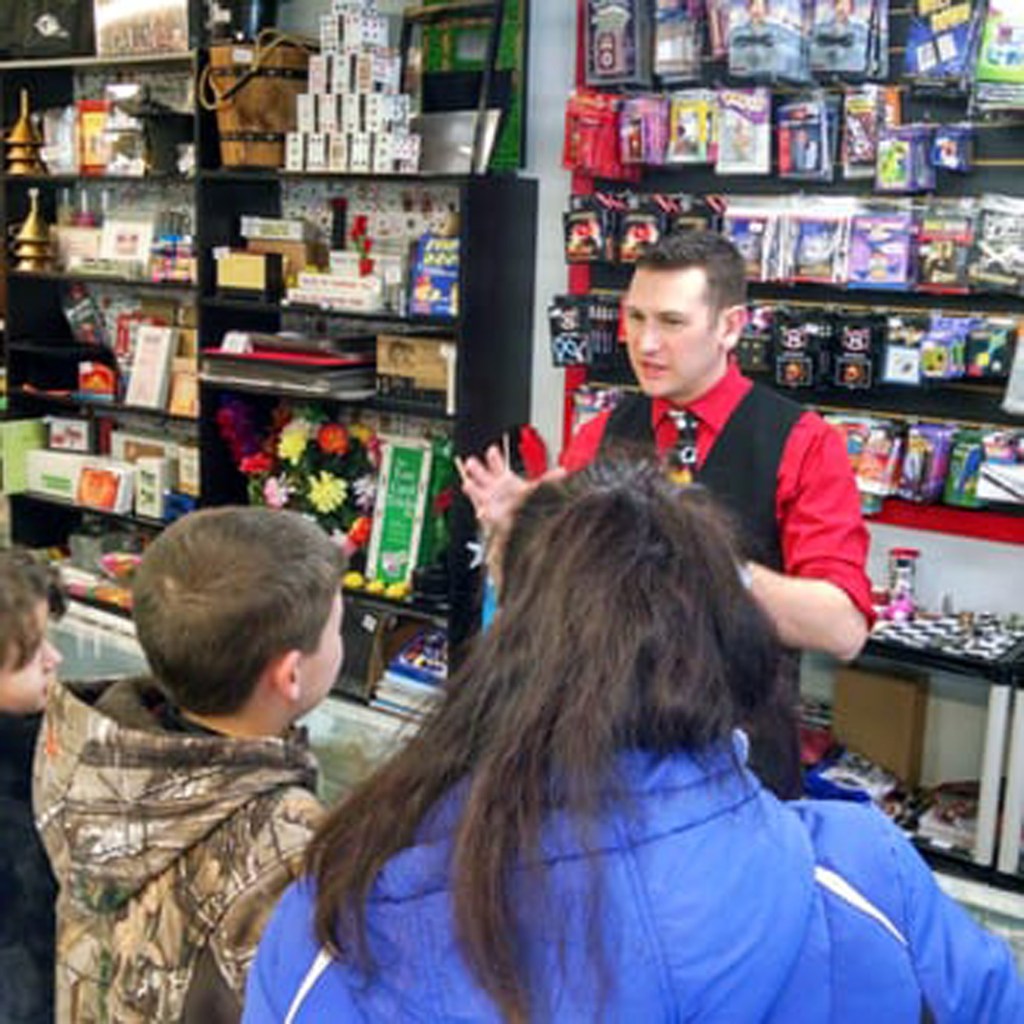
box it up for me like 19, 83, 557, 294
285, 0, 420, 174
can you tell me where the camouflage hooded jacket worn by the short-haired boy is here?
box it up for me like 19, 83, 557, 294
34, 681, 319, 1024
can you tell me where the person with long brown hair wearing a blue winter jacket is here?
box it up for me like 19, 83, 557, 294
244, 464, 1024, 1024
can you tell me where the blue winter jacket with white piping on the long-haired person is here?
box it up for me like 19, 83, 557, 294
243, 742, 1024, 1024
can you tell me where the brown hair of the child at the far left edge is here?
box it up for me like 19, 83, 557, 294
0, 548, 66, 672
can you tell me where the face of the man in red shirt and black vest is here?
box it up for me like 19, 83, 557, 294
626, 267, 746, 404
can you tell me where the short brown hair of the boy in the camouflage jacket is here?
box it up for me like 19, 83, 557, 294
132, 507, 344, 715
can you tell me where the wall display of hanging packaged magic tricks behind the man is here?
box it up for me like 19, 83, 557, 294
565, 0, 1024, 544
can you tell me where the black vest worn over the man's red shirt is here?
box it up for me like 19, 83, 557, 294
598, 384, 804, 571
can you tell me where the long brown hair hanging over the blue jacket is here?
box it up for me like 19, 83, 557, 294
307, 464, 777, 1022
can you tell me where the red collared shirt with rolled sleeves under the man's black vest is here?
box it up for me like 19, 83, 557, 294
560, 365, 874, 625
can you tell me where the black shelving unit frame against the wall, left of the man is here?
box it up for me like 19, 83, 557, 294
0, 9, 537, 642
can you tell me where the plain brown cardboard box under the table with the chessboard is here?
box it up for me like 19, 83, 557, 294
833, 669, 928, 785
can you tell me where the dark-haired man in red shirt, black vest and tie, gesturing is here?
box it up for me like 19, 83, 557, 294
462, 231, 871, 790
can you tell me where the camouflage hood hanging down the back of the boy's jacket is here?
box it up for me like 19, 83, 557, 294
35, 680, 315, 912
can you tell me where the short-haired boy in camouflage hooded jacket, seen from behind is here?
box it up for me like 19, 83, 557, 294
35, 508, 343, 1024
